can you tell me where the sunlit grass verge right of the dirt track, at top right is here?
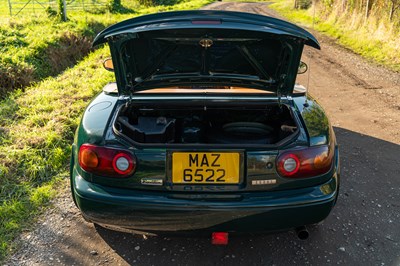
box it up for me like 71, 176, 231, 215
270, 0, 400, 71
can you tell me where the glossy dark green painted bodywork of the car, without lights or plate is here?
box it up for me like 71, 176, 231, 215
70, 12, 340, 233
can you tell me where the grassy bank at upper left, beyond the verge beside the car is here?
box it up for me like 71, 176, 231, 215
0, 0, 216, 98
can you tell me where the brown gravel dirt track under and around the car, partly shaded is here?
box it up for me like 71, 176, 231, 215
3, 2, 400, 265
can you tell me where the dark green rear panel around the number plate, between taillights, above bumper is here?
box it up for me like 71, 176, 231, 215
78, 149, 335, 193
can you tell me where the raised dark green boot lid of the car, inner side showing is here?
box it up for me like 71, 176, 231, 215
93, 10, 319, 96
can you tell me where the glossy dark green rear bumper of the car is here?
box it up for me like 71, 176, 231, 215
72, 171, 338, 234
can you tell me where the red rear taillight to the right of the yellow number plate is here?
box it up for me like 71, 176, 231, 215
276, 145, 334, 178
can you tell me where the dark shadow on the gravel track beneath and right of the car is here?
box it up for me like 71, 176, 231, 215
91, 128, 400, 265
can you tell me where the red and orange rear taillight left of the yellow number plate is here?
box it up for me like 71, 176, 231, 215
78, 144, 136, 177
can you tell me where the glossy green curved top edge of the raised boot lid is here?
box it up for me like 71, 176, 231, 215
93, 10, 320, 49
